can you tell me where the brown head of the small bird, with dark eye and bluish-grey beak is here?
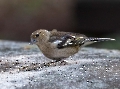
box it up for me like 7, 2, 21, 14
30, 29, 50, 44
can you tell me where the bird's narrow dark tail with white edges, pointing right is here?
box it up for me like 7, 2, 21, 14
79, 37, 115, 46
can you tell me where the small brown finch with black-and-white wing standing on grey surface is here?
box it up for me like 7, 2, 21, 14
30, 29, 115, 61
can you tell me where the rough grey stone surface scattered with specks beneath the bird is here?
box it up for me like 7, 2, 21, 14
0, 40, 120, 89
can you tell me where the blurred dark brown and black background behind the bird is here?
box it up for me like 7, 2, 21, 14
0, 0, 120, 49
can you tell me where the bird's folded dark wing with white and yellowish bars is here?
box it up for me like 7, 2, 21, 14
49, 31, 86, 49
